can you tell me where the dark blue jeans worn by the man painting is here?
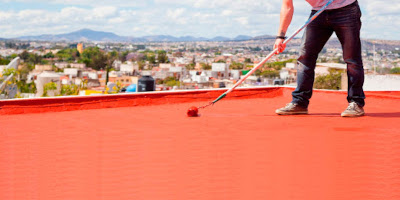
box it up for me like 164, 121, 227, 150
292, 1, 365, 107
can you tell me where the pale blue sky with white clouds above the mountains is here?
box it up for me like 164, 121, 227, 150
0, 0, 400, 40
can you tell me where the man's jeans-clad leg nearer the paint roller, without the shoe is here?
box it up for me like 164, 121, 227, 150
292, 11, 333, 108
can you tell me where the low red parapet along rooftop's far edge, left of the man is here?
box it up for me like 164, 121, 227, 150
0, 87, 283, 115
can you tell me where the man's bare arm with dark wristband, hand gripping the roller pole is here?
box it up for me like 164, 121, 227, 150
274, 0, 294, 53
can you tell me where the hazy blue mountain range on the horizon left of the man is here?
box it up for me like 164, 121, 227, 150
13, 29, 274, 42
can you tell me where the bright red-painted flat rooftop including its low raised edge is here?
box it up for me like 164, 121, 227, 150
0, 88, 400, 200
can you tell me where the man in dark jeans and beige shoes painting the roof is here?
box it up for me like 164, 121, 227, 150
274, 0, 365, 117
